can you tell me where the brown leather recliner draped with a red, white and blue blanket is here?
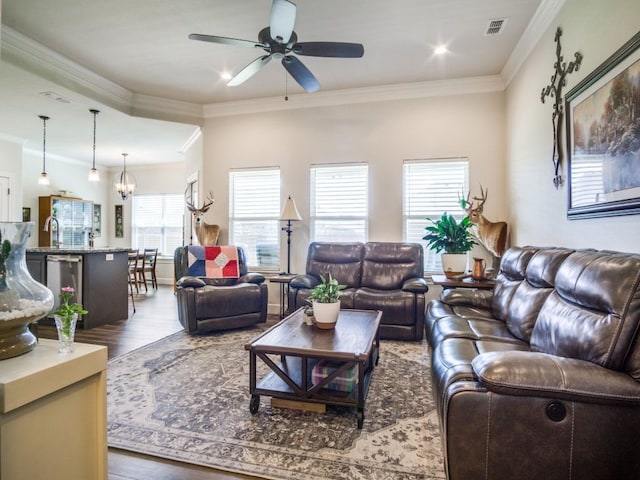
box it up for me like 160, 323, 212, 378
174, 246, 267, 334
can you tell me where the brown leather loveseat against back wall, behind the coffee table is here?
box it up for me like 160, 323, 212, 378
289, 242, 429, 340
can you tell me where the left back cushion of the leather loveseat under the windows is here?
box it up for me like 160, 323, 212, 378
306, 242, 364, 288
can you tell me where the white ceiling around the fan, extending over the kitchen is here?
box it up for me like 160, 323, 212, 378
0, 0, 548, 169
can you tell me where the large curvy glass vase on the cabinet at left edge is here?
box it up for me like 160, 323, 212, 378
0, 222, 53, 360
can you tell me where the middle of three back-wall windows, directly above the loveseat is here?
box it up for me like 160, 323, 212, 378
311, 164, 369, 242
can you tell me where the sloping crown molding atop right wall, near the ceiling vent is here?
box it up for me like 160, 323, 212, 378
500, 0, 566, 86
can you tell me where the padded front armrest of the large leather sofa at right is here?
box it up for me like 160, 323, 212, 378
471, 351, 640, 406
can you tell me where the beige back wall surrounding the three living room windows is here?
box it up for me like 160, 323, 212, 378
203, 92, 506, 272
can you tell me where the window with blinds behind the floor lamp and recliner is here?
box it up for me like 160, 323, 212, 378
229, 168, 280, 270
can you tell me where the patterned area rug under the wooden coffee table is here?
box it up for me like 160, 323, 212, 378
107, 327, 445, 480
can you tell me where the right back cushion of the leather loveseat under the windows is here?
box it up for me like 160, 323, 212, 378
361, 242, 424, 290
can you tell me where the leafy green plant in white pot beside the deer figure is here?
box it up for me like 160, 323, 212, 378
422, 212, 476, 278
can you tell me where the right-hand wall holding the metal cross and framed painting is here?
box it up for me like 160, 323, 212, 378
506, 0, 640, 252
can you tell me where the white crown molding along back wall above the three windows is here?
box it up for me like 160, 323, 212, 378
204, 75, 505, 118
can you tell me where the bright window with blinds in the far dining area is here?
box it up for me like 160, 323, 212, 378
131, 194, 184, 256
